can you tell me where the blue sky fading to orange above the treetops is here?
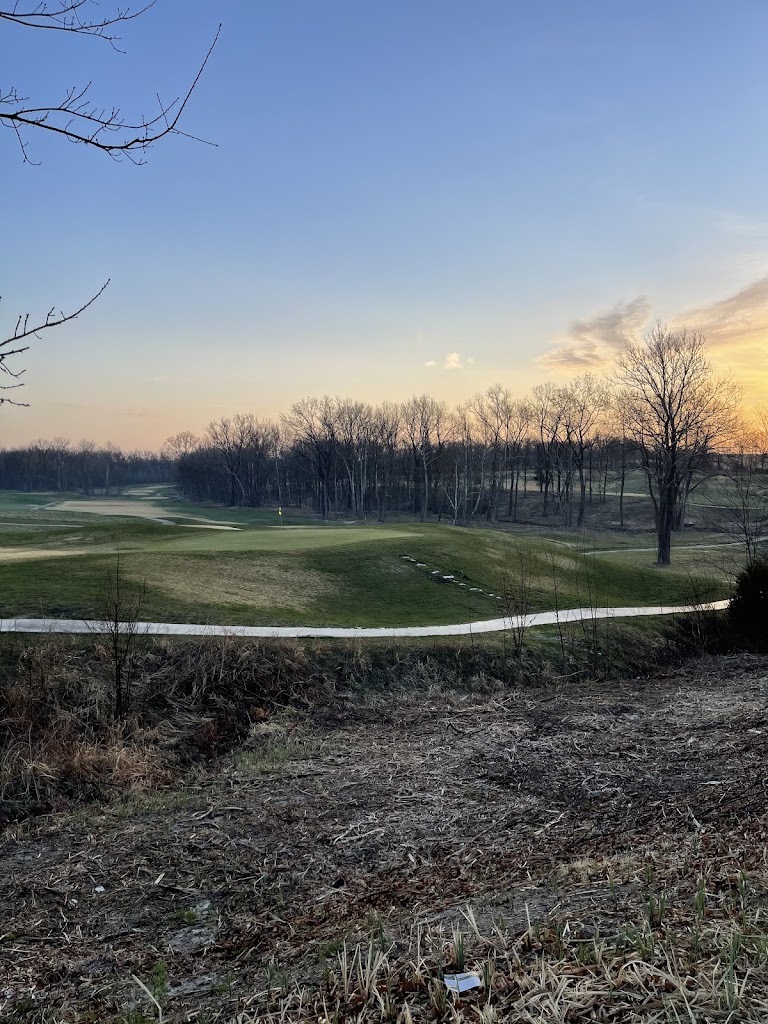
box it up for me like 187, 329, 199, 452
0, 0, 768, 449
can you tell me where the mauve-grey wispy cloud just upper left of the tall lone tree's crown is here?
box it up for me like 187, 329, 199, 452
539, 295, 650, 371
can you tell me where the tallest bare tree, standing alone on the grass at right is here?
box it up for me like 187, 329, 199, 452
616, 324, 740, 565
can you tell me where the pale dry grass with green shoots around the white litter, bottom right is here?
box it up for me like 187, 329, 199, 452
229, 871, 768, 1024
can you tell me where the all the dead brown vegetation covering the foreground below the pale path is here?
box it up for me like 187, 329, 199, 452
0, 640, 768, 1024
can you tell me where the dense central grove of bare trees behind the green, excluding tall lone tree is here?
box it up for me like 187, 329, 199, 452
164, 385, 618, 524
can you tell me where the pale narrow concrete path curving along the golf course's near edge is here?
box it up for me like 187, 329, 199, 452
0, 601, 728, 640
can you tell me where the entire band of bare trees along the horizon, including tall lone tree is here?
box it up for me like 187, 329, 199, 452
0, 325, 768, 564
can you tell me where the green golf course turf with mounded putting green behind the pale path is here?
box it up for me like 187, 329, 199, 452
0, 487, 740, 627
